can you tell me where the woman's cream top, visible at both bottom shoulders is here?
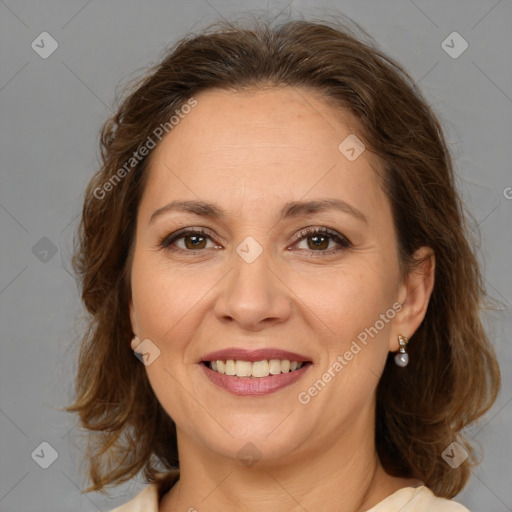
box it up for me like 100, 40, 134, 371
112, 484, 469, 512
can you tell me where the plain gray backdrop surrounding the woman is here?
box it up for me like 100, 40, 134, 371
0, 0, 512, 512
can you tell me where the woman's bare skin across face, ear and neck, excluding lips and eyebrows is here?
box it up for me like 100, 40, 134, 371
130, 87, 434, 512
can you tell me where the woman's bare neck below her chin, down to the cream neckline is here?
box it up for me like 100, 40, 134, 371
160, 412, 421, 512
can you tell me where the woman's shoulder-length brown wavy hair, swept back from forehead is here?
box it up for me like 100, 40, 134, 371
67, 14, 500, 498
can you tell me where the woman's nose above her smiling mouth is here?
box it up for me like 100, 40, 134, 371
214, 245, 292, 331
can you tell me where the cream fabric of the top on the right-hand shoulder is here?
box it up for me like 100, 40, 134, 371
367, 486, 470, 512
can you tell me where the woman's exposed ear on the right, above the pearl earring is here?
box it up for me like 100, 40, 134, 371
389, 247, 435, 352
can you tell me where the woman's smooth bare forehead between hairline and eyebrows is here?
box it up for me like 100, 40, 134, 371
138, 87, 383, 223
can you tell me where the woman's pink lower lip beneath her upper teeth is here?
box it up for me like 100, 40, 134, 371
201, 363, 312, 396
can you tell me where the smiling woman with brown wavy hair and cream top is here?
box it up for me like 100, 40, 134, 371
69, 14, 499, 512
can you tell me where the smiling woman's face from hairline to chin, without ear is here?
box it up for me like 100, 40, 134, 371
130, 87, 410, 460
